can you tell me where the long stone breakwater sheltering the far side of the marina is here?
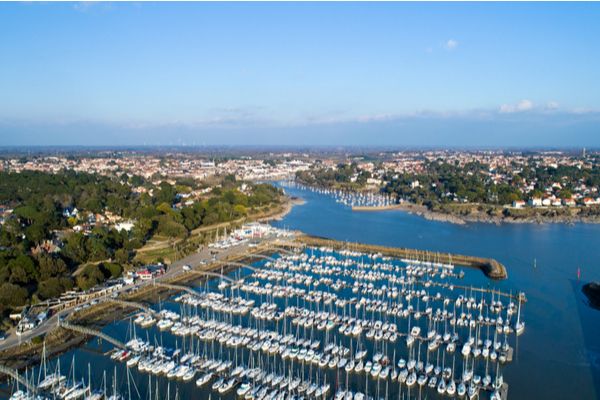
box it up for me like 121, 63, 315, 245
286, 235, 508, 280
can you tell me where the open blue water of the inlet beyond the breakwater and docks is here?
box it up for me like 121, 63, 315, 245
275, 183, 600, 399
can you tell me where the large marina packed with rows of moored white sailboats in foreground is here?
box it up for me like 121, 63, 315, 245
2, 246, 525, 399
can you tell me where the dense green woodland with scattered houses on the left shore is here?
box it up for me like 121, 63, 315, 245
0, 171, 281, 313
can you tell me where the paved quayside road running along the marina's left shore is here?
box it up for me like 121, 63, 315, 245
0, 238, 284, 351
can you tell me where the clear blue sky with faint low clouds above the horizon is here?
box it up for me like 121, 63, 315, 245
0, 2, 600, 147
